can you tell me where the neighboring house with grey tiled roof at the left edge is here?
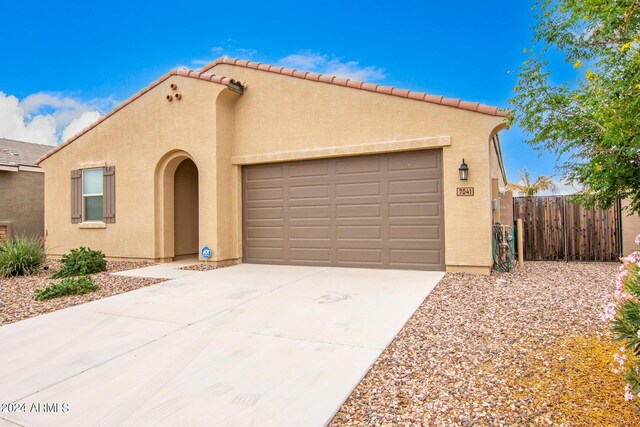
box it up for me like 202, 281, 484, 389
0, 138, 53, 241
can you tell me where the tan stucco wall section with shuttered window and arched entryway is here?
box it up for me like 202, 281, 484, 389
41, 76, 235, 259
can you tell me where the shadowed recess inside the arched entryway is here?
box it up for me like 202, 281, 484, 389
173, 159, 198, 257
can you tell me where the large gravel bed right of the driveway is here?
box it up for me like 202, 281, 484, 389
331, 262, 638, 426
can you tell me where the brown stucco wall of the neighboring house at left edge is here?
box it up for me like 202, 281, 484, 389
0, 171, 44, 236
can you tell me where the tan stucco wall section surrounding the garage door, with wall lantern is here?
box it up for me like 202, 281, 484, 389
212, 64, 503, 268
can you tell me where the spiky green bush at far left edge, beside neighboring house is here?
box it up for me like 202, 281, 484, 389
0, 237, 46, 277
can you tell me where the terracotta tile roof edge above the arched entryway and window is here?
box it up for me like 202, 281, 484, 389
36, 68, 244, 164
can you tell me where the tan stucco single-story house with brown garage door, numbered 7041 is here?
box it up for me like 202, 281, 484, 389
39, 57, 506, 274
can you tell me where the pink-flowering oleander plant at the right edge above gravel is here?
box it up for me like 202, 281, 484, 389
603, 235, 640, 407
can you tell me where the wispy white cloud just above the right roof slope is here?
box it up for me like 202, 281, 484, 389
278, 50, 385, 82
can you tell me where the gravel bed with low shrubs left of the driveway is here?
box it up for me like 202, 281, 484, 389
0, 260, 165, 326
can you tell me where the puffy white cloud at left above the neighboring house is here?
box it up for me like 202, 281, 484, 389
0, 92, 110, 145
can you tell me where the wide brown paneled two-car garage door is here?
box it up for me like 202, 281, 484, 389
243, 150, 444, 270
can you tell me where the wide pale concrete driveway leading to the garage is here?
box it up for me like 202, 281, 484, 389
0, 264, 443, 426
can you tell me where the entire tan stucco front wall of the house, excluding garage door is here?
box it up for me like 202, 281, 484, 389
42, 64, 503, 273
